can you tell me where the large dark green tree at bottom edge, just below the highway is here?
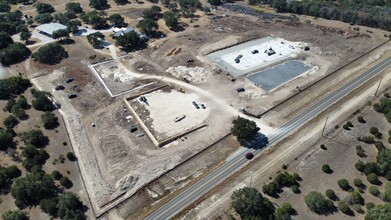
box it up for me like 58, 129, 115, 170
231, 187, 274, 219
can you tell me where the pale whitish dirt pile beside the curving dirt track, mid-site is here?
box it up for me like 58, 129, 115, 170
166, 66, 212, 83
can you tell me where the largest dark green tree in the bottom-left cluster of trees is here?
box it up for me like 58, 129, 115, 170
11, 172, 58, 208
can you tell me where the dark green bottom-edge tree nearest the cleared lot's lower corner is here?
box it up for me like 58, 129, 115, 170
57, 192, 85, 220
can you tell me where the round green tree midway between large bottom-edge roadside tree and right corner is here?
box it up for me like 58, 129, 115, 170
304, 191, 334, 214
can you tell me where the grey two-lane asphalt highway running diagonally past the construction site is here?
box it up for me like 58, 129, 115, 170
145, 57, 391, 220
